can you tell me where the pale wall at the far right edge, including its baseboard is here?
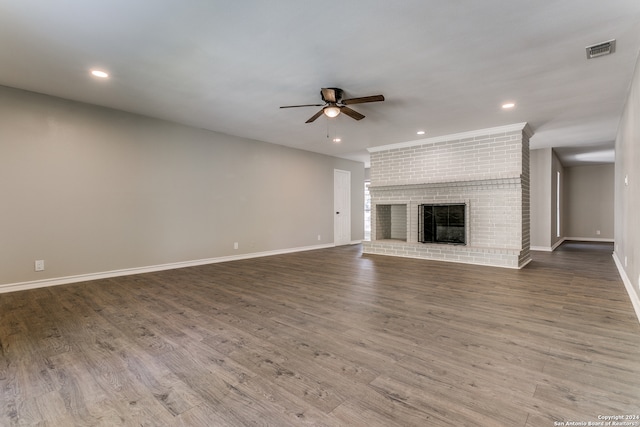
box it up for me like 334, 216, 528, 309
614, 52, 640, 318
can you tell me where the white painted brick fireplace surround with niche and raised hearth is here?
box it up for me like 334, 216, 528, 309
363, 123, 533, 268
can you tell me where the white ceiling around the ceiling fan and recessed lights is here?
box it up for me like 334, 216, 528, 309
0, 0, 640, 164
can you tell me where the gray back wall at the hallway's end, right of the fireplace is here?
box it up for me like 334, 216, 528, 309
564, 163, 615, 241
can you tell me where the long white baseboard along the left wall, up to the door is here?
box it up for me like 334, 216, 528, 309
0, 243, 335, 294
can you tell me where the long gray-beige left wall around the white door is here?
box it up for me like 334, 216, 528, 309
0, 87, 364, 285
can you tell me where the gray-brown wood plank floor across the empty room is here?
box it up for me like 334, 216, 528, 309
0, 243, 640, 427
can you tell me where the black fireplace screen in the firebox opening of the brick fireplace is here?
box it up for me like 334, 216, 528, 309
418, 204, 466, 245
